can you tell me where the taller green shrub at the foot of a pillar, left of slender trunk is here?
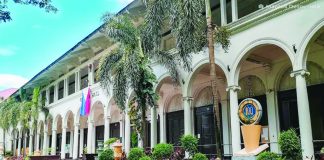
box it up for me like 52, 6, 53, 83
180, 135, 198, 156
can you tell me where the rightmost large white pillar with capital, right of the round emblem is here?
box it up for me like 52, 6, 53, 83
291, 70, 314, 159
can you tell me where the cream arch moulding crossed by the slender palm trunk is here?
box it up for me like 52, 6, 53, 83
184, 57, 228, 96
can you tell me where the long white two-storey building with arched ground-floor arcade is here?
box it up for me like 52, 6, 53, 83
1, 0, 324, 159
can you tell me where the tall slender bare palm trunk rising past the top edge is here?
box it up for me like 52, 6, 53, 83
205, 0, 222, 158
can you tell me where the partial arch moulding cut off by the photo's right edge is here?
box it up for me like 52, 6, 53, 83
296, 18, 324, 70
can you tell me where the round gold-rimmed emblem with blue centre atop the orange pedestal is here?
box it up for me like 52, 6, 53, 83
238, 98, 262, 125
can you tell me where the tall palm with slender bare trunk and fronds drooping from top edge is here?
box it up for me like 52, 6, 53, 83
145, 0, 230, 158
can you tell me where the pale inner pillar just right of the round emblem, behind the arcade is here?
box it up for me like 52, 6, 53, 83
266, 91, 279, 153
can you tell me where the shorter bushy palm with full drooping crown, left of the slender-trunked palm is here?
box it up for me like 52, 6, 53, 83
97, 13, 179, 146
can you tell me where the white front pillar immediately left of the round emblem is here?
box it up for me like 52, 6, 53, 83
227, 86, 241, 154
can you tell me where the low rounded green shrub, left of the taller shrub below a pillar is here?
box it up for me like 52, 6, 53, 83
152, 143, 173, 160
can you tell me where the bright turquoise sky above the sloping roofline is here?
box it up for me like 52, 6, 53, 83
0, 0, 133, 91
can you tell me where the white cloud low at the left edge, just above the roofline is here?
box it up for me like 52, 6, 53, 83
0, 74, 28, 89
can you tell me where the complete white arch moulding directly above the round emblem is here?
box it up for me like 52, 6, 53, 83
229, 38, 295, 85
